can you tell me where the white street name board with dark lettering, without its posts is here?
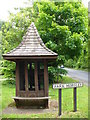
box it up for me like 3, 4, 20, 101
53, 83, 83, 89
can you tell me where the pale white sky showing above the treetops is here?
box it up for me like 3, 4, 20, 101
0, 0, 90, 21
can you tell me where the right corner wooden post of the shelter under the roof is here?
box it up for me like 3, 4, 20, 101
44, 60, 48, 97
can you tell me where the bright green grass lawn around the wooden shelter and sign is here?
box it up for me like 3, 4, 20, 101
2, 77, 88, 118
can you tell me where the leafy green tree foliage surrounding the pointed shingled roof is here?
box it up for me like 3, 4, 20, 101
2, 1, 88, 77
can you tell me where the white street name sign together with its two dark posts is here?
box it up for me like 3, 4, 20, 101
53, 83, 83, 116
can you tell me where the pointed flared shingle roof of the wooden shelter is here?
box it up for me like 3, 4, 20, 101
3, 22, 57, 57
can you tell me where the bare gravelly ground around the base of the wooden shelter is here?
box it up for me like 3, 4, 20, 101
2, 100, 58, 114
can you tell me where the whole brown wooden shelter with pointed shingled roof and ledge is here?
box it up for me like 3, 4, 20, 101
3, 22, 57, 108
